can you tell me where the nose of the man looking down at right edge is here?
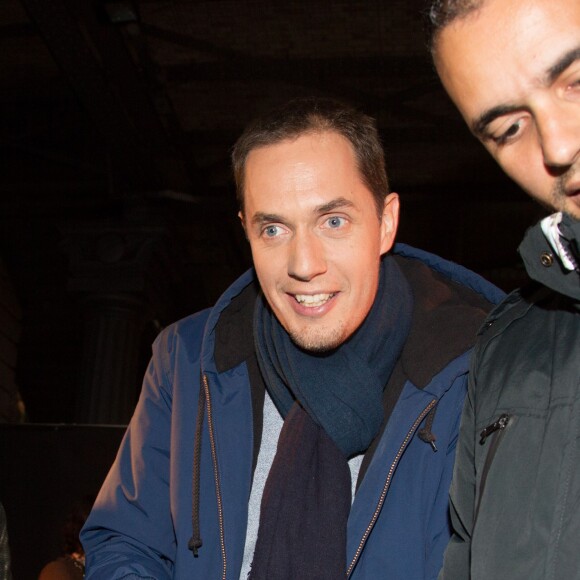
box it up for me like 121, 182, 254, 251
538, 103, 580, 170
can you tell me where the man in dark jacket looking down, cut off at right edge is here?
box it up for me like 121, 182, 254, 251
431, 0, 580, 580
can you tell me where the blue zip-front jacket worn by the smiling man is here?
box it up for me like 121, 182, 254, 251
82, 245, 503, 580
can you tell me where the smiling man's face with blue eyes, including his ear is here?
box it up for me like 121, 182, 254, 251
240, 132, 399, 351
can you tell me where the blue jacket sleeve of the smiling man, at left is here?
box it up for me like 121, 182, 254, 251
81, 327, 181, 580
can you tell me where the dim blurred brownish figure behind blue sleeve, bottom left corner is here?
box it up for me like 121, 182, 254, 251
38, 495, 95, 580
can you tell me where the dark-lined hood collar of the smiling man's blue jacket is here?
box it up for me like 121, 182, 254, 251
211, 244, 504, 388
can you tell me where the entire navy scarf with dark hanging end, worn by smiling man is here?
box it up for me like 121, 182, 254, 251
249, 257, 413, 580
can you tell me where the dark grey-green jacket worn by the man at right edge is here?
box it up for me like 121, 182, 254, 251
439, 218, 580, 580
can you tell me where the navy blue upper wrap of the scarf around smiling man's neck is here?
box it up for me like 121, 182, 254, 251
254, 256, 413, 457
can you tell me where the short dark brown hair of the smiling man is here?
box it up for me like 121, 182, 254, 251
232, 97, 389, 216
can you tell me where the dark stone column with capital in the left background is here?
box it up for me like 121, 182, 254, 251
64, 211, 178, 424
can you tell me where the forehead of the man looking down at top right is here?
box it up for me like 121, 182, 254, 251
434, 0, 580, 123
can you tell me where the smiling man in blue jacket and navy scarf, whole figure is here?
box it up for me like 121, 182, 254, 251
83, 99, 501, 580
